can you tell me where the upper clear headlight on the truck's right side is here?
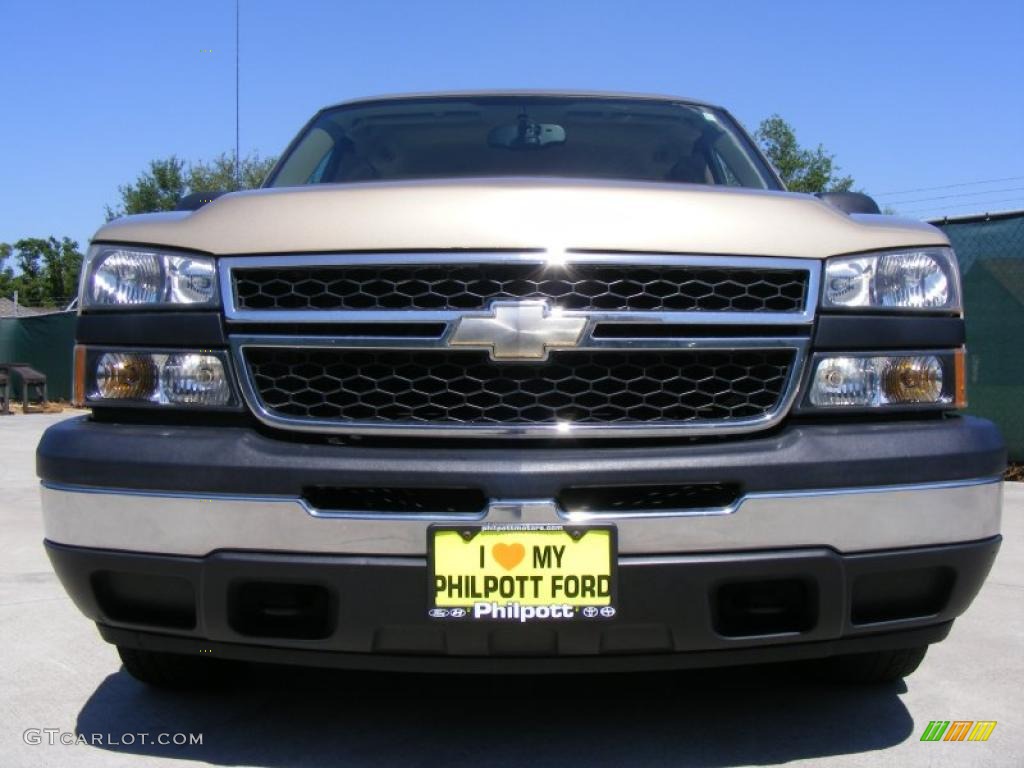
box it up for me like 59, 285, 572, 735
821, 248, 961, 311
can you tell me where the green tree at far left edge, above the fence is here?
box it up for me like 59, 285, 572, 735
0, 237, 82, 307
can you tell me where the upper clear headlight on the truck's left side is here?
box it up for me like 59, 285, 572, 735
80, 245, 217, 309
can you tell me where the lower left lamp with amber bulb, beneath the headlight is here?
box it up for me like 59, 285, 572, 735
75, 346, 239, 409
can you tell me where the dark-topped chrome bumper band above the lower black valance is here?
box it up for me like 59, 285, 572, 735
38, 418, 1006, 556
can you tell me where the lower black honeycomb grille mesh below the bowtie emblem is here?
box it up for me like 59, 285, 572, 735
244, 347, 796, 426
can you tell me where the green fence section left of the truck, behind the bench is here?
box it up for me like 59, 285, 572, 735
0, 312, 75, 400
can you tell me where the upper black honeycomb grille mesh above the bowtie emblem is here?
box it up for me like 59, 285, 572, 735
231, 263, 809, 312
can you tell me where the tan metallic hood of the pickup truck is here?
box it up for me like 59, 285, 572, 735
94, 178, 947, 258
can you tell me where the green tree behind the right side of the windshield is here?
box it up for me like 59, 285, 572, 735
755, 115, 853, 193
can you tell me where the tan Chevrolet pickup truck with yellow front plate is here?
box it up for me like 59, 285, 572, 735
37, 91, 1006, 686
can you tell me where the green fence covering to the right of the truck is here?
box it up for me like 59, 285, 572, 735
933, 211, 1024, 461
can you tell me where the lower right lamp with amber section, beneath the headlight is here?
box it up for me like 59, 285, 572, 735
808, 352, 965, 408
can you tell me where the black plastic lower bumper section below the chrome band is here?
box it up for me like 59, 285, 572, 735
47, 537, 999, 672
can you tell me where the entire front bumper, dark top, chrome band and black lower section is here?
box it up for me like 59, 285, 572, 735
37, 418, 1006, 671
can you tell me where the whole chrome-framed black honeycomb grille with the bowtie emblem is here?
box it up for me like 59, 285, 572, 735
230, 256, 820, 436
